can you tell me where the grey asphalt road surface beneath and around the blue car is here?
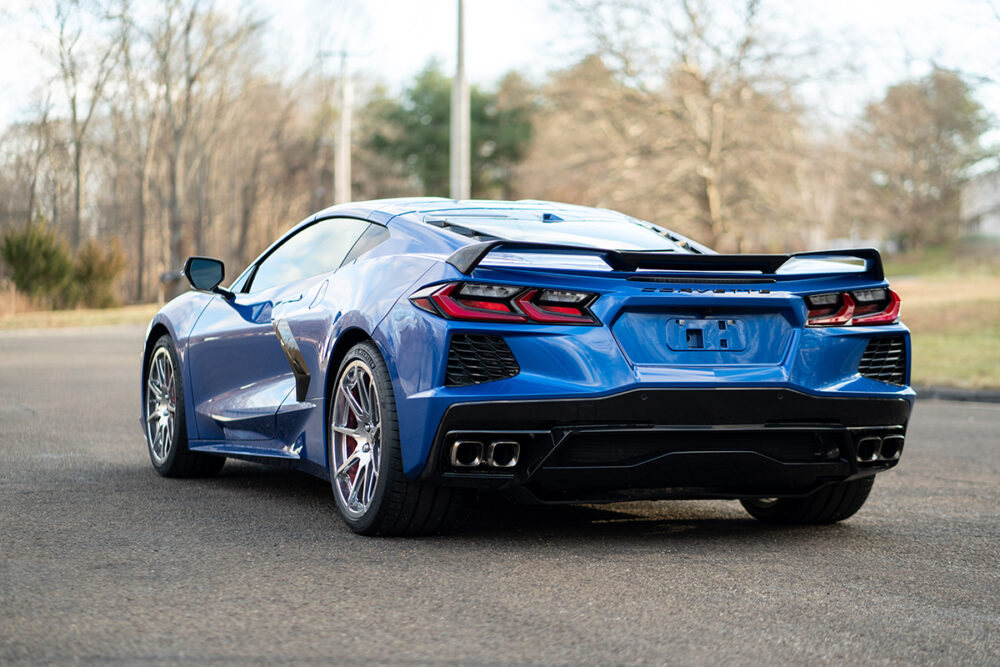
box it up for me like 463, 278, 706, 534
0, 328, 1000, 664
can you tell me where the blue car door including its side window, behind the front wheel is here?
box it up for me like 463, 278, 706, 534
188, 218, 369, 447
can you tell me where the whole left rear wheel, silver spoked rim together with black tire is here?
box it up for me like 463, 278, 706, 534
327, 342, 461, 535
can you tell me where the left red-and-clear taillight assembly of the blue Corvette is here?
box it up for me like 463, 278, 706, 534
410, 283, 599, 324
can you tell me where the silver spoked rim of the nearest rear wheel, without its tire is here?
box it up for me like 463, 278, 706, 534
330, 359, 382, 518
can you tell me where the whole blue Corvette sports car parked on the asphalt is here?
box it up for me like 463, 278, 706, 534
141, 198, 914, 535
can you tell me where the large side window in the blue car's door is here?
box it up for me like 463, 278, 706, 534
250, 218, 369, 292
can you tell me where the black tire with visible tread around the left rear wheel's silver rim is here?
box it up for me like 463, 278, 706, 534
327, 342, 462, 536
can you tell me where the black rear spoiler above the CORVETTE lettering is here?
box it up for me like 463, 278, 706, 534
446, 239, 885, 280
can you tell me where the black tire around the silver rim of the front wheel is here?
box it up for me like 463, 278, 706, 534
142, 335, 226, 477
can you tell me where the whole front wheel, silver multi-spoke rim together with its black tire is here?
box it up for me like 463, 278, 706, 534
144, 336, 226, 477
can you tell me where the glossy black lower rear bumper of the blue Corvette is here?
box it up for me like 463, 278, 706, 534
421, 388, 911, 502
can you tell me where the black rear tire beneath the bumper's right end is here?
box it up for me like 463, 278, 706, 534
740, 475, 875, 524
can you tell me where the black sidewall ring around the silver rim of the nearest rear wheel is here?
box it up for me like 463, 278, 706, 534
326, 342, 399, 533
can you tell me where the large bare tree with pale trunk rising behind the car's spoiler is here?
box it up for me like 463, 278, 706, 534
529, 0, 820, 249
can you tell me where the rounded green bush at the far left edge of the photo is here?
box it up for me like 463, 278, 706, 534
0, 220, 74, 300
